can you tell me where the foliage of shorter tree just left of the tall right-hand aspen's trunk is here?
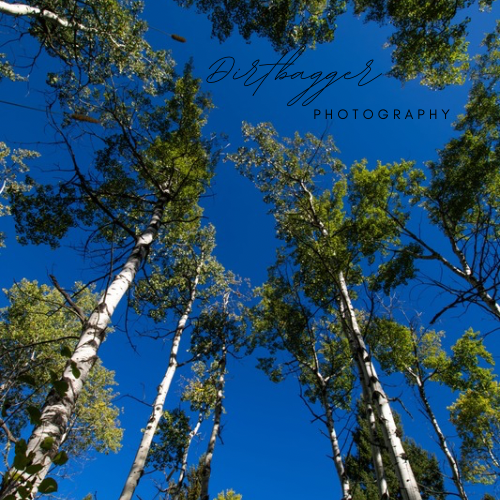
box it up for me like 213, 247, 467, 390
249, 260, 354, 409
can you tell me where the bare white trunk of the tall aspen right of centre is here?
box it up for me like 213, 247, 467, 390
338, 272, 421, 500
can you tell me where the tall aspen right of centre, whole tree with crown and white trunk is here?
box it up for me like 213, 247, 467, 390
231, 124, 421, 500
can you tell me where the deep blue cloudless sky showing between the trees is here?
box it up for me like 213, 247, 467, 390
0, 0, 499, 500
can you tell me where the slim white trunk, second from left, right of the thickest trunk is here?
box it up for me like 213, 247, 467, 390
120, 263, 202, 500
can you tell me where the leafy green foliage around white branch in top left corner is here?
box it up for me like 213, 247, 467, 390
3, 0, 160, 83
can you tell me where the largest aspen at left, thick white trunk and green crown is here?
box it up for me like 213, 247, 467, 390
0, 67, 212, 500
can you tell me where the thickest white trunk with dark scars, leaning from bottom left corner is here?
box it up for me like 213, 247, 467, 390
0, 194, 168, 500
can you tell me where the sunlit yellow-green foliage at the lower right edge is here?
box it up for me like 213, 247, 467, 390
367, 319, 500, 484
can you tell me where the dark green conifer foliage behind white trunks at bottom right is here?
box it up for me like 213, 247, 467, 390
346, 405, 446, 500
